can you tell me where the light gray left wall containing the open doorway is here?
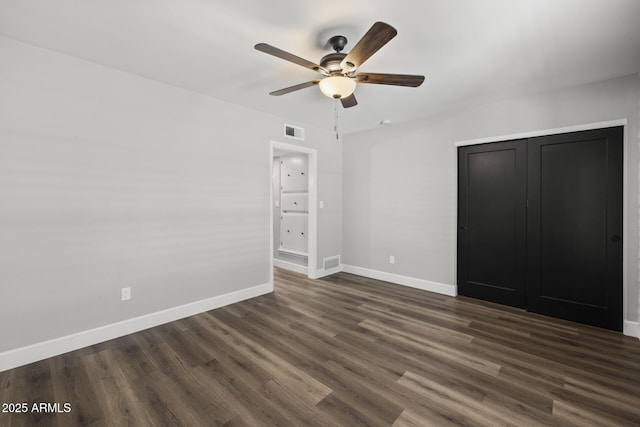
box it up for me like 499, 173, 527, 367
0, 38, 341, 352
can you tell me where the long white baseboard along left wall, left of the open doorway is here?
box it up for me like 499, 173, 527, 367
0, 283, 273, 372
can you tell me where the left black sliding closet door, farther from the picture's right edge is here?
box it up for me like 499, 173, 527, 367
458, 140, 527, 307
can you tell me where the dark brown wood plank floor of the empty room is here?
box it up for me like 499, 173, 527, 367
0, 270, 640, 426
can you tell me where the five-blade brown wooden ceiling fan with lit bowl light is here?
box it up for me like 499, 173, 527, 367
255, 22, 424, 108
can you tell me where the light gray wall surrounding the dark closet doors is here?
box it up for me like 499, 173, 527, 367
342, 75, 640, 321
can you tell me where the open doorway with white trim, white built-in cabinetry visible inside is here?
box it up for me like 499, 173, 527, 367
269, 141, 317, 278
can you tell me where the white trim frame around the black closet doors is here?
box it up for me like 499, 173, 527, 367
453, 119, 636, 336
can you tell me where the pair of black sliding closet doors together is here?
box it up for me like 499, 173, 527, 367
458, 127, 623, 331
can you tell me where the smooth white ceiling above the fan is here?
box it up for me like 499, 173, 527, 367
0, 0, 640, 133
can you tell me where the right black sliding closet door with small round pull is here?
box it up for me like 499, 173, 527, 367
527, 127, 623, 331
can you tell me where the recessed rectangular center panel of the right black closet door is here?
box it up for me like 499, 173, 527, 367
539, 140, 607, 305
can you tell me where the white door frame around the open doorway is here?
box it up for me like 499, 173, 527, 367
269, 140, 318, 280
